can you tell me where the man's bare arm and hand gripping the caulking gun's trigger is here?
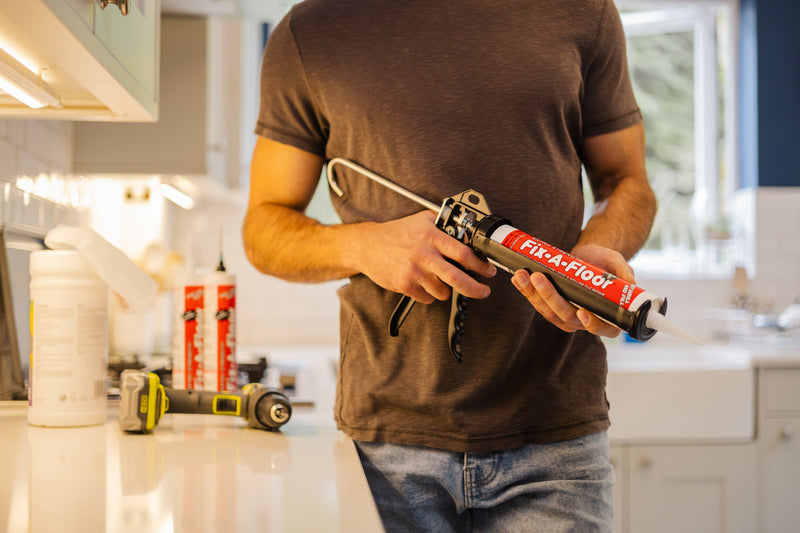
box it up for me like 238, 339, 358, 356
242, 137, 495, 303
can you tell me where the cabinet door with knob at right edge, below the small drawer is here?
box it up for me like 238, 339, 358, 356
761, 418, 800, 533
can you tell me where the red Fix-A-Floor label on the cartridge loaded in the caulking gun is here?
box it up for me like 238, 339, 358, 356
502, 230, 644, 309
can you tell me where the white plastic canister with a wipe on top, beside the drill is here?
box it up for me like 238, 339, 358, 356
28, 250, 108, 426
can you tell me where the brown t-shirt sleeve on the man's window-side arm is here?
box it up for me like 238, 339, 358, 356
582, 0, 642, 137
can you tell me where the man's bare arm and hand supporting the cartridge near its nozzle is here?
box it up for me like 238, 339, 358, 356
512, 124, 656, 337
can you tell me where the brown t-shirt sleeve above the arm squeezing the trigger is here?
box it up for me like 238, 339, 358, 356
255, 12, 328, 157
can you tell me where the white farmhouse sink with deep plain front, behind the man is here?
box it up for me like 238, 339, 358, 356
606, 343, 755, 443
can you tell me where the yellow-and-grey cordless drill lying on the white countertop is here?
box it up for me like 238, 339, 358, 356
119, 369, 292, 433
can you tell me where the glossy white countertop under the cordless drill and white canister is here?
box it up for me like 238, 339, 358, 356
0, 350, 382, 533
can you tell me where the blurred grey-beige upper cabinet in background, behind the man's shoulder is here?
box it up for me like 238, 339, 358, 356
72, 13, 263, 189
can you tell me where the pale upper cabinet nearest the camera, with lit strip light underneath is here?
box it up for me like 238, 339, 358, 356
0, 0, 161, 122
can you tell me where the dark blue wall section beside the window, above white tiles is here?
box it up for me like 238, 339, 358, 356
739, 0, 800, 187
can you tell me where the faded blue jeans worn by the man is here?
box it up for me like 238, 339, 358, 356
356, 432, 614, 533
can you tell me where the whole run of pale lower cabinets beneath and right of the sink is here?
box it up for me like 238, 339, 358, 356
611, 360, 800, 533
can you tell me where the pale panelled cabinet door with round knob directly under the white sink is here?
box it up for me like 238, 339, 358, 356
626, 444, 757, 533
